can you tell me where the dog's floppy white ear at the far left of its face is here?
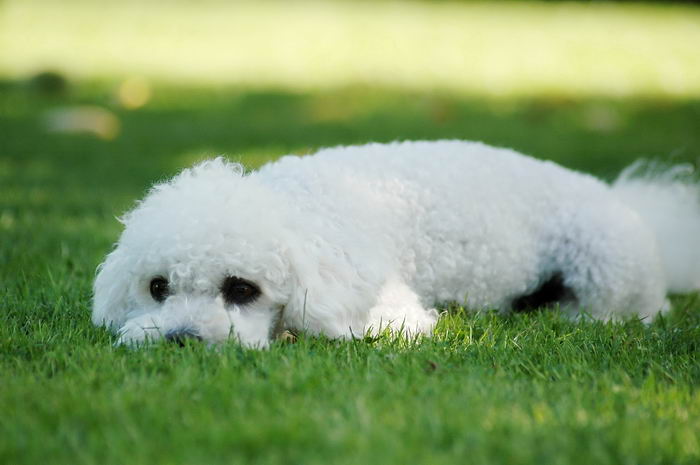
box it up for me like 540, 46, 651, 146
92, 249, 130, 329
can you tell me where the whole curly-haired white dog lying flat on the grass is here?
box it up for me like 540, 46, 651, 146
93, 141, 700, 347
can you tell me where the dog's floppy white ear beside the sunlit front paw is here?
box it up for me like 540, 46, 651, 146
284, 236, 383, 338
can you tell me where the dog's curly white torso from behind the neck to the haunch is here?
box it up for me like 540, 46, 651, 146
258, 141, 700, 316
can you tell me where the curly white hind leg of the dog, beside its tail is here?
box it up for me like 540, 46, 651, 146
551, 203, 668, 321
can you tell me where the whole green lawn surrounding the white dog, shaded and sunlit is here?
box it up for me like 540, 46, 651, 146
0, 0, 700, 464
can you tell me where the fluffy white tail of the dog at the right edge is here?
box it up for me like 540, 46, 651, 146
612, 161, 700, 292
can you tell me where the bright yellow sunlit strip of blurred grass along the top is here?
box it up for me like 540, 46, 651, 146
0, 0, 700, 98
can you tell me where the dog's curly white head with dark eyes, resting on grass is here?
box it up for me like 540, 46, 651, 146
93, 159, 292, 347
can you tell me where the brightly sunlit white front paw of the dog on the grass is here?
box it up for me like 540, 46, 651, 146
365, 278, 438, 337
